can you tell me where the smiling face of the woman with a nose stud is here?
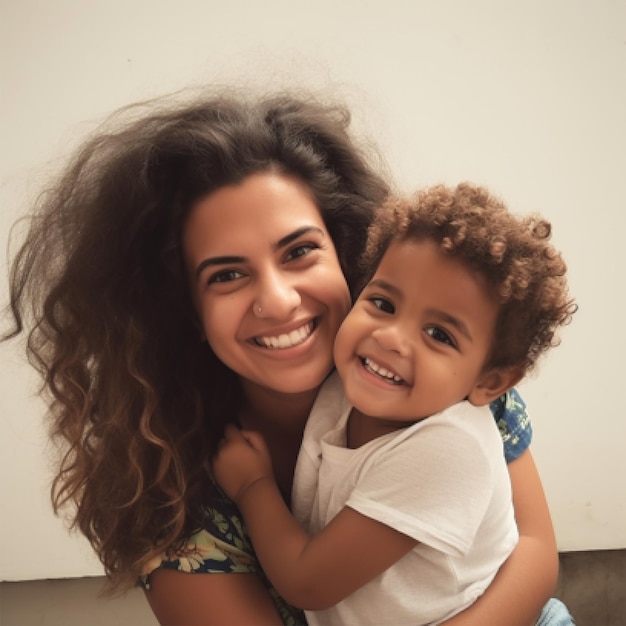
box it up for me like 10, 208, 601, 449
183, 173, 350, 393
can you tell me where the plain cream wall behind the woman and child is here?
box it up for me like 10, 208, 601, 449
0, 0, 626, 580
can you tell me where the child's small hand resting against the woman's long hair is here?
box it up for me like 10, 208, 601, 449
211, 424, 274, 504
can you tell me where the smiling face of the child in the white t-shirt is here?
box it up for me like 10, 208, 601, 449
335, 240, 498, 421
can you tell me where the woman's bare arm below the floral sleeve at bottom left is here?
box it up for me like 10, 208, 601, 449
145, 569, 283, 626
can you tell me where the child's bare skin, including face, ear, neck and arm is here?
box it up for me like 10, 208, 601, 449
213, 240, 520, 610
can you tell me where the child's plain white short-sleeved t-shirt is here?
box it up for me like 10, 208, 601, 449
292, 373, 518, 626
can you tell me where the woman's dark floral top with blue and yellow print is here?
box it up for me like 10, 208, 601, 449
141, 389, 532, 626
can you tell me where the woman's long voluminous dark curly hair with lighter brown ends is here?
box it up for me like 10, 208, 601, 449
4, 93, 388, 589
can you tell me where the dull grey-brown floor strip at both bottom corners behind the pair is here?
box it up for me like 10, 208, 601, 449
0, 550, 626, 626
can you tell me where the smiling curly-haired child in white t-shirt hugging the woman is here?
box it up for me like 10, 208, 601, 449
213, 184, 576, 625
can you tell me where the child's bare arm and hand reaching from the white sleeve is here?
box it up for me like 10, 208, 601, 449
213, 428, 417, 610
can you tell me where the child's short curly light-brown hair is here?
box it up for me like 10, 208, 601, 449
362, 183, 577, 372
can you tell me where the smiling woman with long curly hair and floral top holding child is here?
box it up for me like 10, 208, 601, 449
3, 90, 557, 624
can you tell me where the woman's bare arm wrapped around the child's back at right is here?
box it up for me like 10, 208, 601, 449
438, 449, 559, 626
